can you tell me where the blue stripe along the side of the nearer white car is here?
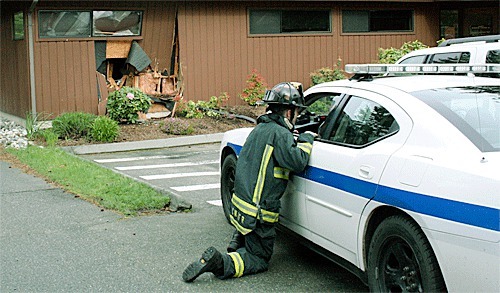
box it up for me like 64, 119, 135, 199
228, 143, 500, 231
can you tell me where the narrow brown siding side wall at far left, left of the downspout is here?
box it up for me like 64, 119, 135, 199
0, 1, 31, 117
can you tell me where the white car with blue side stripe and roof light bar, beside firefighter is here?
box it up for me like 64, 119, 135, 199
220, 64, 500, 292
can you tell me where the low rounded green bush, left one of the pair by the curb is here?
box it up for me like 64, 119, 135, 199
52, 112, 97, 139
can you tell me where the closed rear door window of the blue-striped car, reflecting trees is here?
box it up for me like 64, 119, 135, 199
329, 96, 399, 146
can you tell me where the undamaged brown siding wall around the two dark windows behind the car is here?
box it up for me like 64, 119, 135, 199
178, 2, 439, 104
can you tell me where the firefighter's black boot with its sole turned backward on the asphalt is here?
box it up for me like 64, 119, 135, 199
182, 247, 224, 282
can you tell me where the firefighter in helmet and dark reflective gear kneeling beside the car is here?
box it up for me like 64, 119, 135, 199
182, 82, 316, 282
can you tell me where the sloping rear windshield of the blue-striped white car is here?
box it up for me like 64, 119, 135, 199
412, 86, 500, 152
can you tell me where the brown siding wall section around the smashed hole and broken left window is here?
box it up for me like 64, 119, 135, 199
34, 1, 175, 118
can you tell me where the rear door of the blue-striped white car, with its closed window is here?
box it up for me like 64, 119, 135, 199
304, 89, 411, 265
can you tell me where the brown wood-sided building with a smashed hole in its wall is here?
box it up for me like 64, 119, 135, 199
0, 0, 499, 118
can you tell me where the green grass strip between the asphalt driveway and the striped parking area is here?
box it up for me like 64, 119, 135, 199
0, 146, 170, 216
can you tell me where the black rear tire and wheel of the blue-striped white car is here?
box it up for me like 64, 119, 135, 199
368, 215, 446, 292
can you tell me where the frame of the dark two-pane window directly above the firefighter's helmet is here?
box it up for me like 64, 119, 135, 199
247, 7, 333, 37
